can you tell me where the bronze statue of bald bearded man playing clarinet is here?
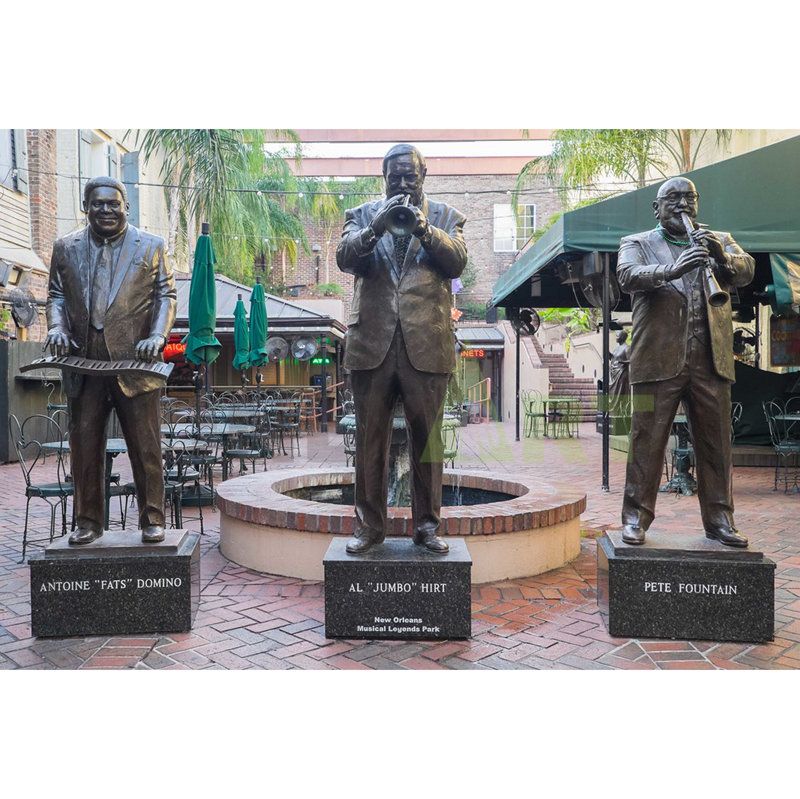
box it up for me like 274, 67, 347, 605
617, 178, 755, 547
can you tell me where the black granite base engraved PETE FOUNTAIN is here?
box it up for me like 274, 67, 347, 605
597, 531, 775, 642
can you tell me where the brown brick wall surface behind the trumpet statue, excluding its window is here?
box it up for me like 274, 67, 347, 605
273, 175, 563, 312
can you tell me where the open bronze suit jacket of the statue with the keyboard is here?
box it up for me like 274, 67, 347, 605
47, 225, 177, 397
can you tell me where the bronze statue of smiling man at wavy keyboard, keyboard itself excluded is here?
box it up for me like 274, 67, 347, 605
44, 177, 177, 545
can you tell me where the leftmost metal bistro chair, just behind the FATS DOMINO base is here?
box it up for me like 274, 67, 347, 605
8, 414, 74, 563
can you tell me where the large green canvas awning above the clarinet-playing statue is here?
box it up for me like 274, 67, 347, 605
490, 136, 800, 305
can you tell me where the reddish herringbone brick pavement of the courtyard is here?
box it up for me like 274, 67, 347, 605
0, 424, 800, 670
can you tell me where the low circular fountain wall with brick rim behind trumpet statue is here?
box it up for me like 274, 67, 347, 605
217, 469, 586, 583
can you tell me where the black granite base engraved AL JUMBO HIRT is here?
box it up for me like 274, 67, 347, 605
323, 538, 472, 640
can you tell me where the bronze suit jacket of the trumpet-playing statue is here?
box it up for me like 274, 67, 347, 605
336, 198, 467, 374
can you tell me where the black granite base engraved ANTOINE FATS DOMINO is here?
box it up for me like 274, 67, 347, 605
29, 530, 200, 637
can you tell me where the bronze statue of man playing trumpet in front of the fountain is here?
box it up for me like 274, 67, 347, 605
336, 144, 467, 554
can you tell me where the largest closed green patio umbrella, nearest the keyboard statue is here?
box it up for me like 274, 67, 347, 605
183, 222, 222, 371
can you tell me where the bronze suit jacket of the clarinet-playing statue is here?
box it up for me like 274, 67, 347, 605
617, 229, 755, 384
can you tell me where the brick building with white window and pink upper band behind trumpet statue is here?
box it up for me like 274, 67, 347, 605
273, 130, 563, 317
